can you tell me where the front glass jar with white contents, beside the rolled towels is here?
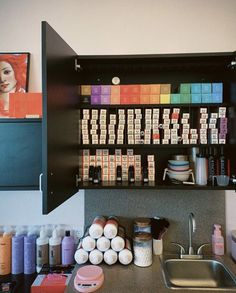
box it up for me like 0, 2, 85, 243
133, 232, 152, 267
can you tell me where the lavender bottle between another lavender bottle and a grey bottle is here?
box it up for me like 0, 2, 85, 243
24, 230, 37, 275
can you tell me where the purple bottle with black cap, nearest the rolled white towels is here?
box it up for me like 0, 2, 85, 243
61, 231, 75, 265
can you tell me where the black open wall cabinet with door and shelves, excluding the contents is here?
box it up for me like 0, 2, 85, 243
42, 22, 236, 213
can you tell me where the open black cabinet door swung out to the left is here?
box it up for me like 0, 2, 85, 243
42, 22, 79, 214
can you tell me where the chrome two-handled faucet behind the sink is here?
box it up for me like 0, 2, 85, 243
172, 213, 210, 259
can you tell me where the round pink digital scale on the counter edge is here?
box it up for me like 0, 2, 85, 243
74, 265, 104, 292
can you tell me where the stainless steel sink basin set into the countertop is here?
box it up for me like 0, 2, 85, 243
162, 259, 236, 291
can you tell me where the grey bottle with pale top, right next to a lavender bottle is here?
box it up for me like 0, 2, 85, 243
36, 228, 49, 269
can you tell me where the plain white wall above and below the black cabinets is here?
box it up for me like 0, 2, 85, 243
0, 0, 236, 242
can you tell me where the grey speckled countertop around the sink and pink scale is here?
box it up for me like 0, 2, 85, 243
66, 256, 236, 293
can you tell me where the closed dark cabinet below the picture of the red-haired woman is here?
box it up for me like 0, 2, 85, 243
0, 119, 42, 190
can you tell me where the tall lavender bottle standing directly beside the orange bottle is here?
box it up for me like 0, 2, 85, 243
11, 227, 24, 275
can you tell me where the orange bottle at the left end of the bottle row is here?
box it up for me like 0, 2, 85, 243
0, 229, 12, 275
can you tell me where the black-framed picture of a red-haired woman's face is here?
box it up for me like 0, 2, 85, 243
0, 53, 30, 117
